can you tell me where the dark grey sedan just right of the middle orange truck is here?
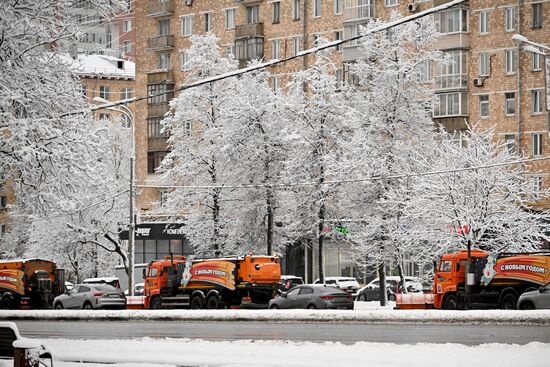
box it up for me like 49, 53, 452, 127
269, 284, 353, 310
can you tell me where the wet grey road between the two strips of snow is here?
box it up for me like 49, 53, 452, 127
15, 321, 550, 345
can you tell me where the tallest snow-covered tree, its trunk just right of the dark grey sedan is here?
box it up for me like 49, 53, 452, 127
345, 13, 441, 303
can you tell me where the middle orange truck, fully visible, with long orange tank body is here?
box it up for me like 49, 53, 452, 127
144, 255, 281, 309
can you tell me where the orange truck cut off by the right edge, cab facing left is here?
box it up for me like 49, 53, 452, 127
433, 250, 550, 309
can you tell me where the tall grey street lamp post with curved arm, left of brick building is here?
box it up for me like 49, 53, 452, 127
94, 97, 136, 296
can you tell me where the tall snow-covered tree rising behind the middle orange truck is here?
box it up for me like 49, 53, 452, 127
160, 35, 237, 256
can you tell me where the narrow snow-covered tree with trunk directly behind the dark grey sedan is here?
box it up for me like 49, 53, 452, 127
284, 46, 351, 280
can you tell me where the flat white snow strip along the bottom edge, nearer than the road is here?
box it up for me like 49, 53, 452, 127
37, 338, 550, 367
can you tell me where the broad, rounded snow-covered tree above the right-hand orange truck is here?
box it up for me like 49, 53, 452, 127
394, 125, 550, 260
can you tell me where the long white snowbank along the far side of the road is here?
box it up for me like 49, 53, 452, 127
0, 302, 550, 325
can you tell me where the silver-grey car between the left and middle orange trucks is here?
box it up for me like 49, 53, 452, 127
53, 284, 126, 310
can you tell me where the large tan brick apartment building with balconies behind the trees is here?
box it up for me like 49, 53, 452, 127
135, 0, 550, 280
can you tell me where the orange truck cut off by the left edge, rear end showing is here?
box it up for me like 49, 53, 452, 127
0, 259, 65, 309
